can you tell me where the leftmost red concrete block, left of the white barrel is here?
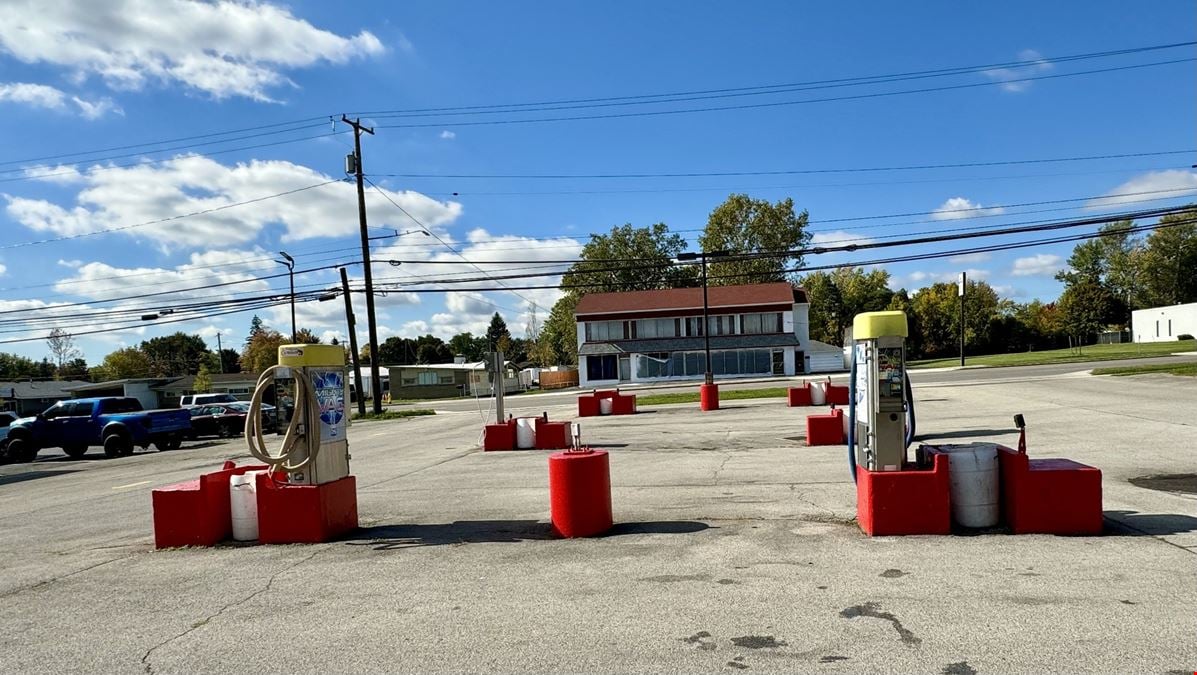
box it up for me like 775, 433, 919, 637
150, 462, 267, 548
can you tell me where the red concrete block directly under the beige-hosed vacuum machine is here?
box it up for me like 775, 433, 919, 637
257, 474, 358, 543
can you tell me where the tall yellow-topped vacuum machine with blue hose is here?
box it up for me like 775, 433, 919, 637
847, 311, 915, 480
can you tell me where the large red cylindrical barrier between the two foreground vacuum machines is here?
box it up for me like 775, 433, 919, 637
548, 450, 613, 537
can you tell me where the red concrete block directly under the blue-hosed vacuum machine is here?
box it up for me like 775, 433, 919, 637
856, 452, 952, 536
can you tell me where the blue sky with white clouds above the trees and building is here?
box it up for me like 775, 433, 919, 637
0, 0, 1197, 363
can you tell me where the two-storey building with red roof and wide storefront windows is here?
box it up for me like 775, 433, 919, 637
575, 282, 843, 388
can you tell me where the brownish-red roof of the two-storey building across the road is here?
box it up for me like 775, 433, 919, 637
575, 281, 807, 316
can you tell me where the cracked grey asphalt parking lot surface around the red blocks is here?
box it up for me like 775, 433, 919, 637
0, 369, 1197, 673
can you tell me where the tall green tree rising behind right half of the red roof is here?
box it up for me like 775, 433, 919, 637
698, 194, 810, 286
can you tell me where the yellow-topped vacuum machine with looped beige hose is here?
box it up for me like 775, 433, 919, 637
245, 345, 350, 485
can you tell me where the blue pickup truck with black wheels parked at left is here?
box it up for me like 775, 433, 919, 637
7, 396, 192, 462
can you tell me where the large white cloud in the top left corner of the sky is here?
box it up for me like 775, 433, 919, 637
0, 0, 384, 101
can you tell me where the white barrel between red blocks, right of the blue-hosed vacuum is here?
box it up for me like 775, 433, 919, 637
936, 443, 1001, 528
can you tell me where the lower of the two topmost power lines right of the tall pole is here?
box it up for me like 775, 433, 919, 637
375, 57, 1197, 129
